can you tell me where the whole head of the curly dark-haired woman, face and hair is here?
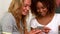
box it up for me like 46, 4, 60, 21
31, 0, 56, 17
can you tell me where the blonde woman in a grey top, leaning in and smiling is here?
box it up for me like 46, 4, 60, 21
1, 0, 30, 34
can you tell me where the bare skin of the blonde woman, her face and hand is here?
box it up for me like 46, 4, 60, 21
22, 0, 41, 34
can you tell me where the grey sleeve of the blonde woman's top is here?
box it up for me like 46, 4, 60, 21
1, 14, 13, 34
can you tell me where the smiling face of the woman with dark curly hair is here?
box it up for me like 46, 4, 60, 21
36, 2, 48, 16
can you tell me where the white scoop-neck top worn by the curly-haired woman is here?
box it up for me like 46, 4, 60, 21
30, 14, 60, 34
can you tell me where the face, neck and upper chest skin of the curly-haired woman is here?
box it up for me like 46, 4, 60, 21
36, 2, 54, 25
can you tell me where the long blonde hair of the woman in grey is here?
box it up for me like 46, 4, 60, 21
8, 0, 26, 34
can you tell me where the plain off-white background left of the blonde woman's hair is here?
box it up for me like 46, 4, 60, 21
0, 0, 12, 20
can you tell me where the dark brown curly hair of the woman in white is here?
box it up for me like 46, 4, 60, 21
31, 0, 56, 16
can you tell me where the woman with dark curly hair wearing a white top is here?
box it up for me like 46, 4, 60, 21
31, 0, 60, 34
